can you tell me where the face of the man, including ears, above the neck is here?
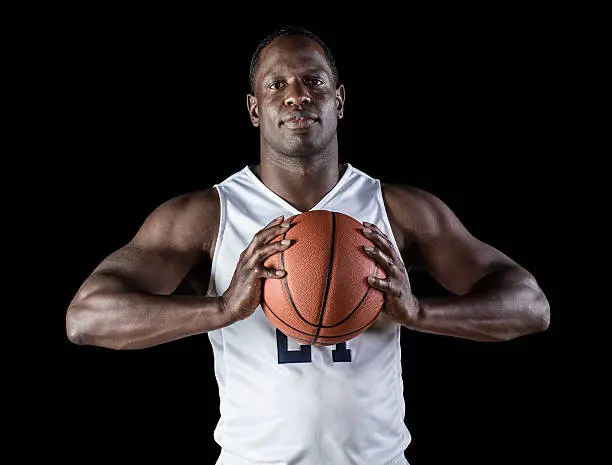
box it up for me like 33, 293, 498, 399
247, 36, 344, 156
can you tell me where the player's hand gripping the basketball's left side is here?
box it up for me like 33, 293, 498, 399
221, 216, 291, 323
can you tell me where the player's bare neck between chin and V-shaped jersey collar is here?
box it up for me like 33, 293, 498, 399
253, 156, 346, 212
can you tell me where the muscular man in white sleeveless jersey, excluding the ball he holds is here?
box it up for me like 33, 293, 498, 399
66, 28, 549, 465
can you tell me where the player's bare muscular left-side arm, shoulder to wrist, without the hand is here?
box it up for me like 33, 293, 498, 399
66, 190, 230, 349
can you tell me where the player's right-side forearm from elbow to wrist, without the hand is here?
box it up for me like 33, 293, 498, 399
405, 269, 550, 341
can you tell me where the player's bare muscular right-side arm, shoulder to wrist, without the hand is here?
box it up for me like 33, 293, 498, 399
384, 186, 550, 341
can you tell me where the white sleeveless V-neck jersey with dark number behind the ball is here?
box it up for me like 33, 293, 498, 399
208, 164, 411, 465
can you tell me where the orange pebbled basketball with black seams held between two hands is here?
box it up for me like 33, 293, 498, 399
262, 210, 386, 346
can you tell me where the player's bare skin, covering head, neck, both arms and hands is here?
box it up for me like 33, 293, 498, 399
66, 36, 550, 349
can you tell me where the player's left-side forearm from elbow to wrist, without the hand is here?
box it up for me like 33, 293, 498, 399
66, 292, 231, 349
